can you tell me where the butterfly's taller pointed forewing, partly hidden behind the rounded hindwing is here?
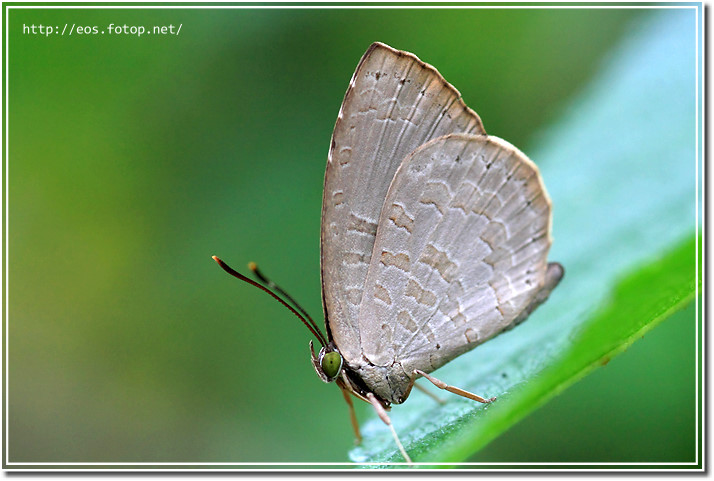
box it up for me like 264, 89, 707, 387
321, 43, 484, 359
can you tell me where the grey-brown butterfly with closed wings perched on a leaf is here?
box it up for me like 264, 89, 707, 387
216, 42, 563, 462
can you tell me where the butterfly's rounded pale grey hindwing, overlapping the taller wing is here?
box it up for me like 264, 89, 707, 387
359, 134, 550, 373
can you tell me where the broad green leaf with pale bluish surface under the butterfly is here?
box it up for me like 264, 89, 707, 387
350, 10, 701, 463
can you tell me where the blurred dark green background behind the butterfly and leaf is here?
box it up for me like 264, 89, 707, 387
6, 8, 696, 462
